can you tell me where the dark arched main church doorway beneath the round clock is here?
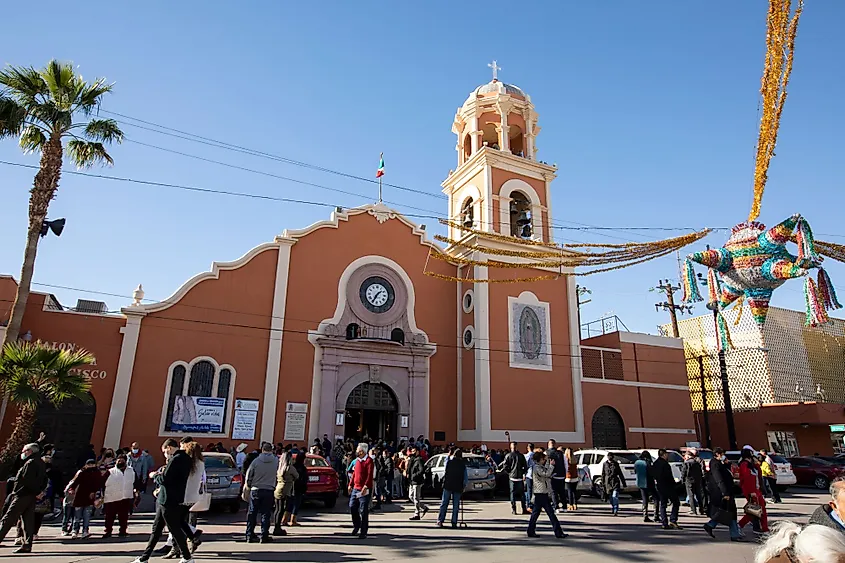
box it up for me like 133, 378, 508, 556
344, 381, 399, 442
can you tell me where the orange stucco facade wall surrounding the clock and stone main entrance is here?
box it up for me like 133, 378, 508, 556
275, 213, 458, 448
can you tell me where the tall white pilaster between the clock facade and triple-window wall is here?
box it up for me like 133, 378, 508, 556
260, 241, 295, 444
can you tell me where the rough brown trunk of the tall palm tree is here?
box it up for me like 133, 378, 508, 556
0, 135, 62, 348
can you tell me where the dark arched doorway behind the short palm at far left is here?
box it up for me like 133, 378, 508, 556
32, 396, 97, 476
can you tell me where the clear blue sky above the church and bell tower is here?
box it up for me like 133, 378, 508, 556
0, 0, 845, 332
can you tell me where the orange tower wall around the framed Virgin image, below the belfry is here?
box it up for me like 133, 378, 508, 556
489, 268, 575, 432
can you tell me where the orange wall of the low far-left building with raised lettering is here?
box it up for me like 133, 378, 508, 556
0, 286, 126, 450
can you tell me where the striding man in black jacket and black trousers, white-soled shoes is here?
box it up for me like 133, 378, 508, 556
133, 438, 193, 563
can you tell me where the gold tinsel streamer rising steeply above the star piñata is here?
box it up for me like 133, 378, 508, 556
748, 0, 804, 221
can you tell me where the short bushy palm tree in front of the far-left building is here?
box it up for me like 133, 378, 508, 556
0, 342, 96, 474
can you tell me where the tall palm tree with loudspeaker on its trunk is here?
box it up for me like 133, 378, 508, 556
0, 61, 123, 342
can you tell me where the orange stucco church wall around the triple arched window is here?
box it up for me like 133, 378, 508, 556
121, 248, 278, 460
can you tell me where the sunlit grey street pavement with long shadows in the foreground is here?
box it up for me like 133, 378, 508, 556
11, 488, 828, 563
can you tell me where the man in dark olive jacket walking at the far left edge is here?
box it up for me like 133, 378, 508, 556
0, 443, 47, 553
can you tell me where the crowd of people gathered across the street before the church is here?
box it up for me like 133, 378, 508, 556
0, 435, 845, 563
